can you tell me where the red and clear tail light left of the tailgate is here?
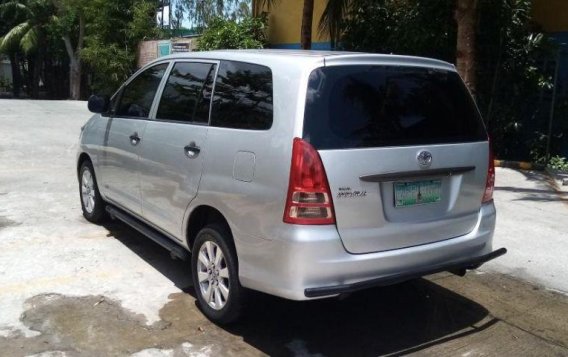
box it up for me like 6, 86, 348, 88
284, 138, 335, 224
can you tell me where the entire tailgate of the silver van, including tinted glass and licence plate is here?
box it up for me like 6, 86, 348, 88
304, 65, 489, 253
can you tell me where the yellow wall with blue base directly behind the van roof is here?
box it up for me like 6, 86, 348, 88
255, 0, 331, 50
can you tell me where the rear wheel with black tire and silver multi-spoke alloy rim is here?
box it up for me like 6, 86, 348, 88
191, 224, 245, 325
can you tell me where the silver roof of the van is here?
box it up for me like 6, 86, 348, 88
157, 49, 455, 71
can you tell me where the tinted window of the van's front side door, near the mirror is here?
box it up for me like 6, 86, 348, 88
116, 63, 168, 118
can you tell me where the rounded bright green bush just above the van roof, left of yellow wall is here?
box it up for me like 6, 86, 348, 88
197, 16, 268, 51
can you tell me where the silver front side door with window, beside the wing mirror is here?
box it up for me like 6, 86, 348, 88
100, 63, 168, 214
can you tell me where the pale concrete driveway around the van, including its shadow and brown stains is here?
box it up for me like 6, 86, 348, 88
0, 100, 568, 356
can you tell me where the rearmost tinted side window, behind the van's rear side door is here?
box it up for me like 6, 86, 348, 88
211, 61, 273, 130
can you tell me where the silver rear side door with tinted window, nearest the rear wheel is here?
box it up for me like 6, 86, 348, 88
140, 61, 217, 237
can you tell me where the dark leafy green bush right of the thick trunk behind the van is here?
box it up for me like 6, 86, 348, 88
478, 0, 555, 162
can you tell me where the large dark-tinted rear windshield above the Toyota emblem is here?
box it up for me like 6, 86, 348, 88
304, 66, 487, 149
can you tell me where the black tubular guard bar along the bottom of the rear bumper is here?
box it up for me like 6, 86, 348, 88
304, 248, 507, 298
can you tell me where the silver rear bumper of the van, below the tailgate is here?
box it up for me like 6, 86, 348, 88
236, 203, 500, 300
